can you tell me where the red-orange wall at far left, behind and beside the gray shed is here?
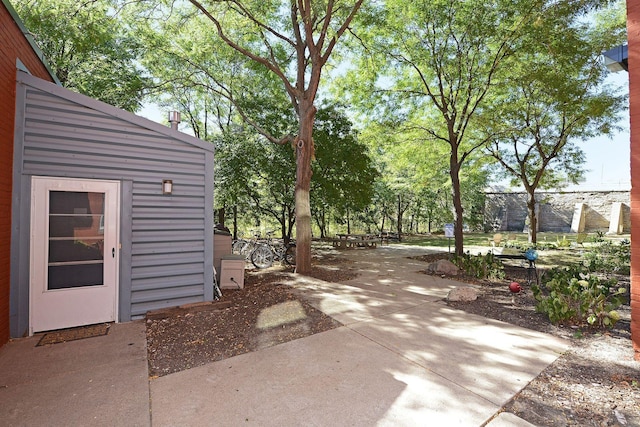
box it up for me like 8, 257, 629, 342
0, 3, 52, 346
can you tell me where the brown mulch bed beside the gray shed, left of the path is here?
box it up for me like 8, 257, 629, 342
147, 269, 341, 377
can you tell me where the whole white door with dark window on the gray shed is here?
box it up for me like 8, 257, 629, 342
29, 177, 120, 334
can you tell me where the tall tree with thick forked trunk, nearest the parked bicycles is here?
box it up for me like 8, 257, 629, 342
171, 0, 362, 274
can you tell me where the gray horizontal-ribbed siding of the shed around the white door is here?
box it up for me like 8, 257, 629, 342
23, 87, 213, 320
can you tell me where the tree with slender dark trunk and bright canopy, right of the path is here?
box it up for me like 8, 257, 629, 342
340, 0, 601, 255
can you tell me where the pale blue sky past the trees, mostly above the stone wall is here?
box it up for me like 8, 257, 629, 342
138, 71, 631, 191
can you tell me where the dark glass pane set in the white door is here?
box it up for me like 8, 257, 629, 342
47, 191, 104, 289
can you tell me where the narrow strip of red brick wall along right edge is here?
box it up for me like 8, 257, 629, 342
627, 0, 640, 360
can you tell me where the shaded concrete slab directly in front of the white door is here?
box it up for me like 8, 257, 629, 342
0, 321, 150, 426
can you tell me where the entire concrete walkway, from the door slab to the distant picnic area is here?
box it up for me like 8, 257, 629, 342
0, 245, 567, 427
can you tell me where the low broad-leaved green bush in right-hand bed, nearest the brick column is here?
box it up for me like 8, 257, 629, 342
531, 265, 626, 328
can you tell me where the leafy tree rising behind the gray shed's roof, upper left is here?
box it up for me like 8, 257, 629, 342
13, 0, 148, 112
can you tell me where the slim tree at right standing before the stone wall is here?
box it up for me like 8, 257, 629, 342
486, 5, 626, 243
